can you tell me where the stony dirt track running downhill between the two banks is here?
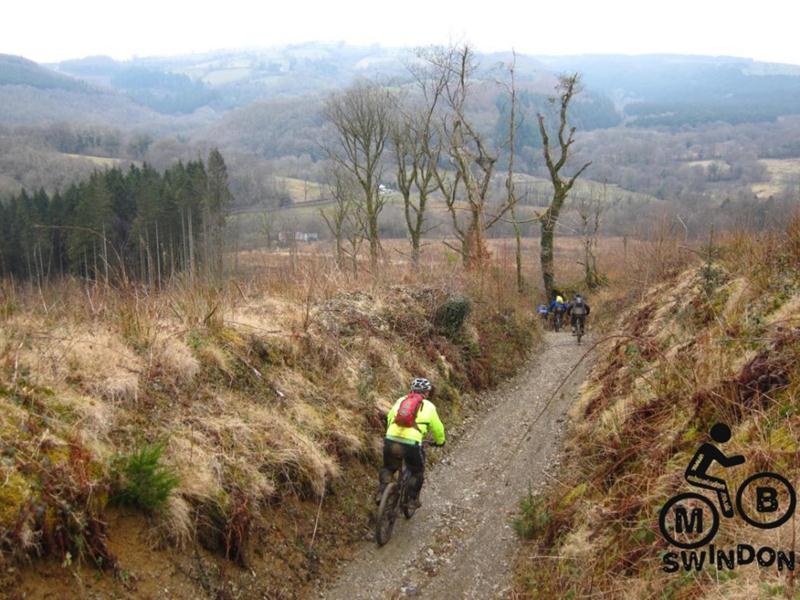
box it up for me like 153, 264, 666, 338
318, 332, 589, 600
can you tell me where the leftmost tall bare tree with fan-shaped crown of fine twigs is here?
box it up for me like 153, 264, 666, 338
325, 81, 392, 273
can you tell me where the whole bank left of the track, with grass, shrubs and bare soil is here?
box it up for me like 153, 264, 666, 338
0, 257, 536, 597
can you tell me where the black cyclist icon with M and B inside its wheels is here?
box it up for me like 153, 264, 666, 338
658, 423, 797, 549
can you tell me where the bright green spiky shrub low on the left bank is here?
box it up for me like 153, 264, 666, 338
111, 443, 179, 512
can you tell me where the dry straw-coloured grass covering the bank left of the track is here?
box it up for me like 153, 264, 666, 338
0, 237, 560, 584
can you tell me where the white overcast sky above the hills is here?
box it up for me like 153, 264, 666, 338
6, 0, 800, 64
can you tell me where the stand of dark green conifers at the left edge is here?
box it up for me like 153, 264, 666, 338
0, 150, 232, 284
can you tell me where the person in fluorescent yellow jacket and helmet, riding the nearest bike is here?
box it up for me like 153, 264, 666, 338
376, 377, 445, 508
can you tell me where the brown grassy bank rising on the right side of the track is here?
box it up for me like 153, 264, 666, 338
515, 220, 800, 598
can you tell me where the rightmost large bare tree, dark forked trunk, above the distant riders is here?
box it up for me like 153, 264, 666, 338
538, 73, 592, 299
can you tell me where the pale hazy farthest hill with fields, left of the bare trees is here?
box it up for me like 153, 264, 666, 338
53, 43, 408, 113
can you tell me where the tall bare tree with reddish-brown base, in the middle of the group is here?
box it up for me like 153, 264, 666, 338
422, 45, 511, 268
